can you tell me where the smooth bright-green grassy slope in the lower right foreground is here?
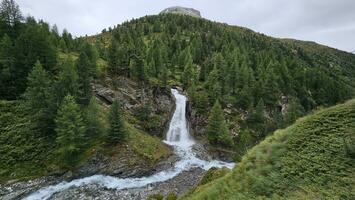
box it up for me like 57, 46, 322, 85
184, 100, 355, 199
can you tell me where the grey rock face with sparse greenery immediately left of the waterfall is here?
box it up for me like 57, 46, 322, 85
92, 77, 175, 138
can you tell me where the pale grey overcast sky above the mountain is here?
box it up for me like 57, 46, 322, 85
16, 0, 355, 51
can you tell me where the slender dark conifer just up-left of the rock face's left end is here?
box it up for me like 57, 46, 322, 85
76, 52, 92, 106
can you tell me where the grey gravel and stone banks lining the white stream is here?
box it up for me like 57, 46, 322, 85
0, 145, 208, 200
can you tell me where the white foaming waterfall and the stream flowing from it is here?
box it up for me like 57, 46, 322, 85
24, 89, 234, 200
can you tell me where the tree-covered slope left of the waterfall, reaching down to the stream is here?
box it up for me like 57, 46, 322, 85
0, 0, 170, 181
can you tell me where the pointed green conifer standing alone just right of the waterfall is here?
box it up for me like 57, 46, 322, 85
206, 101, 233, 147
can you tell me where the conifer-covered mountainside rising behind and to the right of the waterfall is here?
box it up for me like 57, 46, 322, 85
86, 14, 355, 159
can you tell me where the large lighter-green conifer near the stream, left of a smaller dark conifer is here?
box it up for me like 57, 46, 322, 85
55, 95, 86, 168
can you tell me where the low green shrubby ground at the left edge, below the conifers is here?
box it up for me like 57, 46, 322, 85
0, 101, 54, 181
